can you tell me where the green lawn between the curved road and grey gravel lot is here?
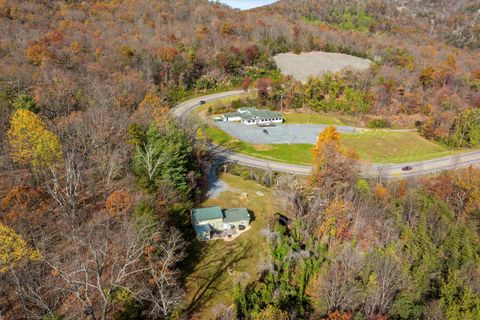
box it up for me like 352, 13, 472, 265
202, 127, 458, 165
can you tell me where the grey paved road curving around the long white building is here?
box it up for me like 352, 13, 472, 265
172, 90, 480, 178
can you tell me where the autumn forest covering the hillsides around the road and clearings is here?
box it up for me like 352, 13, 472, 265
0, 0, 480, 320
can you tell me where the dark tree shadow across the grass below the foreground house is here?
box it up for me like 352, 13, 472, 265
186, 240, 253, 314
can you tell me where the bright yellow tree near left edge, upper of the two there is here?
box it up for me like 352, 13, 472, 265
7, 109, 61, 168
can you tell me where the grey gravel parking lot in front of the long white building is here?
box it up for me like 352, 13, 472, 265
215, 122, 358, 144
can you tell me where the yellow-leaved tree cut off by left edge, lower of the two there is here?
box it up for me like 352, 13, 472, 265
0, 223, 41, 273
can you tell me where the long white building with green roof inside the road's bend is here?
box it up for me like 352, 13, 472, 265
221, 108, 284, 125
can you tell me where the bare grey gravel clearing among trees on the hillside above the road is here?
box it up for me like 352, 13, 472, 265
273, 51, 371, 82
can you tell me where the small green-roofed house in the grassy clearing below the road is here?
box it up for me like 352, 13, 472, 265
192, 206, 251, 240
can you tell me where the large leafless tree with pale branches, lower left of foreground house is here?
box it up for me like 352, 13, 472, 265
45, 215, 184, 320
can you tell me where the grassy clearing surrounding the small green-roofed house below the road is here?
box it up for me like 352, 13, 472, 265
186, 174, 279, 319
